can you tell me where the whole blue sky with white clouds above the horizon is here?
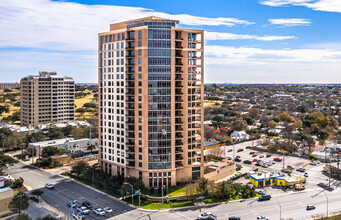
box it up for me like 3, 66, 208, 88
0, 0, 341, 83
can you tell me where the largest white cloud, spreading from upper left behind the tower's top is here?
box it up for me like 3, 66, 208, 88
0, 0, 252, 50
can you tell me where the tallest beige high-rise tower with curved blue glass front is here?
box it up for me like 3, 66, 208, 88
98, 17, 204, 187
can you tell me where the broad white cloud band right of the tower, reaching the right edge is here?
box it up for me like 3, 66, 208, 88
205, 45, 341, 65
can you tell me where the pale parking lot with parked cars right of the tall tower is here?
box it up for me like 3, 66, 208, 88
216, 141, 326, 188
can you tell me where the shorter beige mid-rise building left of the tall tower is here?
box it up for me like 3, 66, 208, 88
20, 72, 75, 127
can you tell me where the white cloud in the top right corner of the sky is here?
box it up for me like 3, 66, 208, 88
260, 0, 341, 13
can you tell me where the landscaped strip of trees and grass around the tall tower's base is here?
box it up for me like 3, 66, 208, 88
61, 162, 259, 210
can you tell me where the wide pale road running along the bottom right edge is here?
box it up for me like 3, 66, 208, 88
111, 188, 341, 220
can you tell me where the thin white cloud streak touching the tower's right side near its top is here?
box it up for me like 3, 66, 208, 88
205, 32, 295, 41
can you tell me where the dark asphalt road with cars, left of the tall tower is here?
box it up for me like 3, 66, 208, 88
9, 162, 133, 219
